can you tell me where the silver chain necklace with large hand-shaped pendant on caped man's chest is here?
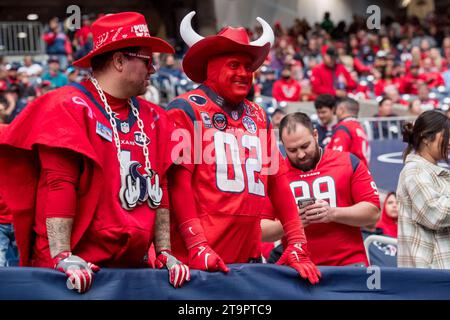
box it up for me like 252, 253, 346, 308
89, 76, 162, 210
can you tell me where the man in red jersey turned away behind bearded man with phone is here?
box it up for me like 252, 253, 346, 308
327, 98, 370, 166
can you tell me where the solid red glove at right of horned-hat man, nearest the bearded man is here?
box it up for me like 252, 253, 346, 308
277, 219, 322, 284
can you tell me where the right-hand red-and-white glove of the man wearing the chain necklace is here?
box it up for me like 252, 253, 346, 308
155, 250, 191, 288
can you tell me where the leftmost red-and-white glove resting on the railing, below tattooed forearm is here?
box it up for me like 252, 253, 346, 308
53, 251, 100, 293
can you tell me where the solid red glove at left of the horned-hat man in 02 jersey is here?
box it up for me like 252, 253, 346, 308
189, 242, 230, 273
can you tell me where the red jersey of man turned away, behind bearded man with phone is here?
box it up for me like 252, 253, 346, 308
327, 117, 370, 166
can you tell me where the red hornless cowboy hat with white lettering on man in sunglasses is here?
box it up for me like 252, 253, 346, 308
73, 12, 174, 68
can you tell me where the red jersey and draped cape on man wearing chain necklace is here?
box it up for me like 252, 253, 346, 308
2, 82, 173, 267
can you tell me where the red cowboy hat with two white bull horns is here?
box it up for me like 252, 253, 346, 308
180, 11, 274, 83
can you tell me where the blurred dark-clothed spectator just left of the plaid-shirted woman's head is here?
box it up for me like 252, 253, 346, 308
372, 97, 399, 139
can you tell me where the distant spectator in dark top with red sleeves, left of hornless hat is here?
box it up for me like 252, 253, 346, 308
44, 17, 72, 70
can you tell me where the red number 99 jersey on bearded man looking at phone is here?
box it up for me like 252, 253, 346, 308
286, 150, 380, 266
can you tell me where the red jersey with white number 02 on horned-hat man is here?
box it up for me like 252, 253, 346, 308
168, 85, 283, 263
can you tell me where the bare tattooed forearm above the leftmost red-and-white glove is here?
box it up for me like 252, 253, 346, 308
46, 218, 73, 258
